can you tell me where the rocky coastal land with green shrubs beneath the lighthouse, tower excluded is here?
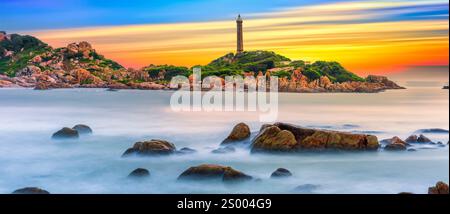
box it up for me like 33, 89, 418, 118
0, 32, 402, 93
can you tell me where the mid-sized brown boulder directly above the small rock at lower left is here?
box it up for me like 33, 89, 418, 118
122, 140, 176, 157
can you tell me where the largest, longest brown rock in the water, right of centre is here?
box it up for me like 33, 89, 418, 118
252, 123, 379, 152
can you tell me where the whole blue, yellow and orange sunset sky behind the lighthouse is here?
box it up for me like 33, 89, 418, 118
0, 0, 449, 75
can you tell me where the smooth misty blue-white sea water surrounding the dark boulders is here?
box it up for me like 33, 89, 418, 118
0, 87, 449, 194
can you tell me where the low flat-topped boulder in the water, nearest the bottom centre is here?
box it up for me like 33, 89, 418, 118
178, 164, 252, 182
